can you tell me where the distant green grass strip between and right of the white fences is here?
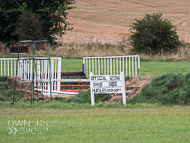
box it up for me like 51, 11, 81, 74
61, 59, 190, 77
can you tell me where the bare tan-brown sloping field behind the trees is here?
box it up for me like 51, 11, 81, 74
59, 0, 190, 43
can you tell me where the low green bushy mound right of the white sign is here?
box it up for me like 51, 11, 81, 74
127, 72, 190, 105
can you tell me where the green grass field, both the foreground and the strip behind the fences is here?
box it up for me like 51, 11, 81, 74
0, 59, 190, 143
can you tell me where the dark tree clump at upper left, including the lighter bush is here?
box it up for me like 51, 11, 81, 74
0, 0, 74, 43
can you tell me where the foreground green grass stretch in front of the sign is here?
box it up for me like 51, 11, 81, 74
0, 103, 190, 143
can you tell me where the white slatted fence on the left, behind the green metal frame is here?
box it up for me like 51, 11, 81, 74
0, 57, 61, 91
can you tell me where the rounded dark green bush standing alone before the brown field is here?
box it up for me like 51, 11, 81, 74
128, 13, 181, 54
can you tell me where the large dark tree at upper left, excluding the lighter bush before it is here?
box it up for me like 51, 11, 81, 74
0, 0, 74, 43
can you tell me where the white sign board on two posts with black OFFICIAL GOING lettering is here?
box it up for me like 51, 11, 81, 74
90, 72, 126, 106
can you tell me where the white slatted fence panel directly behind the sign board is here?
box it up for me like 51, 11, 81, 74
83, 55, 140, 78
